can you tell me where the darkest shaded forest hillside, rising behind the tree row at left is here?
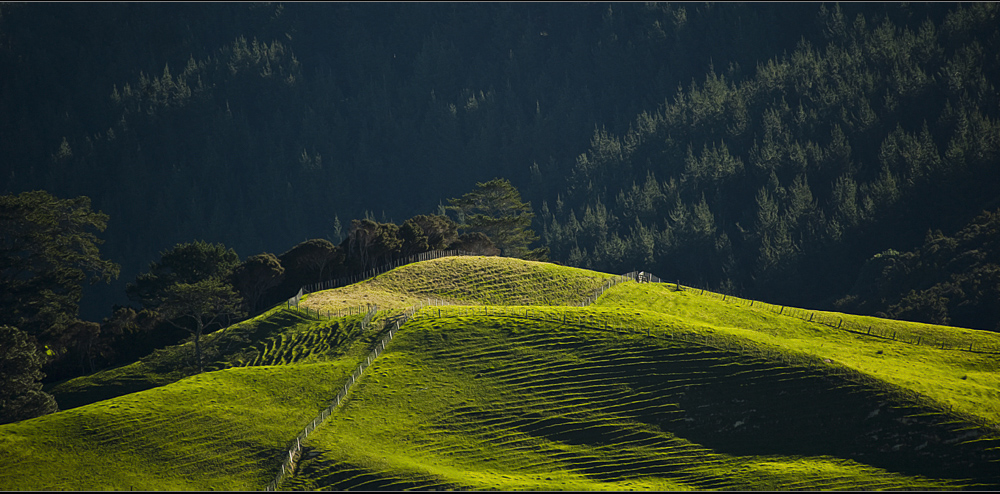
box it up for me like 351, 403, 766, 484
0, 3, 840, 317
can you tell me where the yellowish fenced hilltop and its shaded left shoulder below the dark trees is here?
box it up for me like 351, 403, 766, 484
52, 256, 612, 410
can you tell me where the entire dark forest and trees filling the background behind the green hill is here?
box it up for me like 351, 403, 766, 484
0, 2, 1000, 407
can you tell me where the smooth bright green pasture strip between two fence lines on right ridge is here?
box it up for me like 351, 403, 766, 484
595, 282, 1000, 426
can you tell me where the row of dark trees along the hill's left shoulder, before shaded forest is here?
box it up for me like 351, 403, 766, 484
0, 179, 546, 423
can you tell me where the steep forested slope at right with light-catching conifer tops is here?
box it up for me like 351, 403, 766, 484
542, 3, 1000, 329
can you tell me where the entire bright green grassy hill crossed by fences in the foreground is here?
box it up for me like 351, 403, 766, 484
0, 257, 1000, 490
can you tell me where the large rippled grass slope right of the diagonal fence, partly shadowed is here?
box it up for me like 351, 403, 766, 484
283, 307, 1000, 490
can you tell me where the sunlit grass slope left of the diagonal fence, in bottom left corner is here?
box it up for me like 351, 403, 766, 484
0, 360, 354, 491
